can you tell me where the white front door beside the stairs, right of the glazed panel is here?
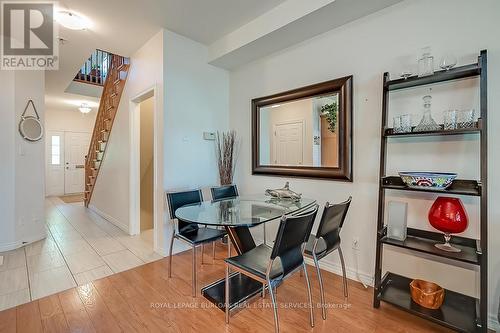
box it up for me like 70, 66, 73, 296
64, 132, 90, 194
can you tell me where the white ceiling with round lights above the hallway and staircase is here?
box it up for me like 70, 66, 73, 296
45, 0, 284, 112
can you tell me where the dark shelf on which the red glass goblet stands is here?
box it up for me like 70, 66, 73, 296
380, 228, 480, 265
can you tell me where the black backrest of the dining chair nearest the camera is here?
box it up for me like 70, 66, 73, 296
271, 205, 318, 277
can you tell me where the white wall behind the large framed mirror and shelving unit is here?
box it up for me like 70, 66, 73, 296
230, 0, 500, 325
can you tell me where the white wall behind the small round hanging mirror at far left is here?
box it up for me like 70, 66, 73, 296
0, 71, 46, 252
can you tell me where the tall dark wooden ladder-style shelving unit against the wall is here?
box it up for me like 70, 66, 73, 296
373, 50, 488, 332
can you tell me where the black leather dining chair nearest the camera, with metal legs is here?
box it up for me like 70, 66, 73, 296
225, 205, 318, 333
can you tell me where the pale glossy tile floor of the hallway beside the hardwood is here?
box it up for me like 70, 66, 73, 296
0, 197, 162, 311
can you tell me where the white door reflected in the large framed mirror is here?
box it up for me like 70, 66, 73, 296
274, 121, 304, 165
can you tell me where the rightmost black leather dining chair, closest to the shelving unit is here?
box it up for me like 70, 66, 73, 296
304, 197, 352, 319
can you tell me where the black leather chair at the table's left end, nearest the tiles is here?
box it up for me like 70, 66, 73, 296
167, 190, 226, 297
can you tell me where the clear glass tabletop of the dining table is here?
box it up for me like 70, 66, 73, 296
175, 195, 316, 227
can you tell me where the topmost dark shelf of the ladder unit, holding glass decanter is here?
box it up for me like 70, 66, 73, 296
384, 64, 481, 91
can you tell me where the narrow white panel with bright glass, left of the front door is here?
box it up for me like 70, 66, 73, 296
45, 131, 64, 196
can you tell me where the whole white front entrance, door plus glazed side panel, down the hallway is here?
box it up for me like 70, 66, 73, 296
45, 131, 91, 196
